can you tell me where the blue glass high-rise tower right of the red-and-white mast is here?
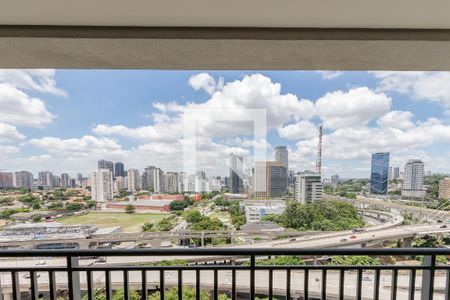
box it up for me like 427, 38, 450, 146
370, 152, 389, 195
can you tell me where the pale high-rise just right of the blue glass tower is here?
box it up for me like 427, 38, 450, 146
402, 159, 426, 198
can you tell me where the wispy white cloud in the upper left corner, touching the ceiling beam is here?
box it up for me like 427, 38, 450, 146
0, 69, 67, 97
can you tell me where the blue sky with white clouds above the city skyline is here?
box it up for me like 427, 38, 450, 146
0, 70, 450, 177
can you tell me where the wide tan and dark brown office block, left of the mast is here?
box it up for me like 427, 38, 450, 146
253, 161, 287, 197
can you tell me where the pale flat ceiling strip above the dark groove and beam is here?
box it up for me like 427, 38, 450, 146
0, 0, 450, 29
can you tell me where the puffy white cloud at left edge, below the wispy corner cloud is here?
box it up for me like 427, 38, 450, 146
0, 83, 54, 127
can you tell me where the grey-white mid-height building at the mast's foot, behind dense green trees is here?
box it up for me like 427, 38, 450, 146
295, 171, 322, 204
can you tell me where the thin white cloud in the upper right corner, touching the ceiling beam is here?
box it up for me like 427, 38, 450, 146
373, 72, 450, 108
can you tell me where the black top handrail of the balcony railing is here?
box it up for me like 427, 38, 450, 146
0, 248, 450, 258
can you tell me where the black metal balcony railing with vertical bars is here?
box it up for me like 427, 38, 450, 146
0, 248, 450, 300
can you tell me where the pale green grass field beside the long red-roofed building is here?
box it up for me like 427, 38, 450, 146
57, 212, 168, 232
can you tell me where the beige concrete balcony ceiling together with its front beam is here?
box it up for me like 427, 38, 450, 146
0, 0, 450, 70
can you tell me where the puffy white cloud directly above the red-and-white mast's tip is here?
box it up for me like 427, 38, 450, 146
316, 87, 391, 129
